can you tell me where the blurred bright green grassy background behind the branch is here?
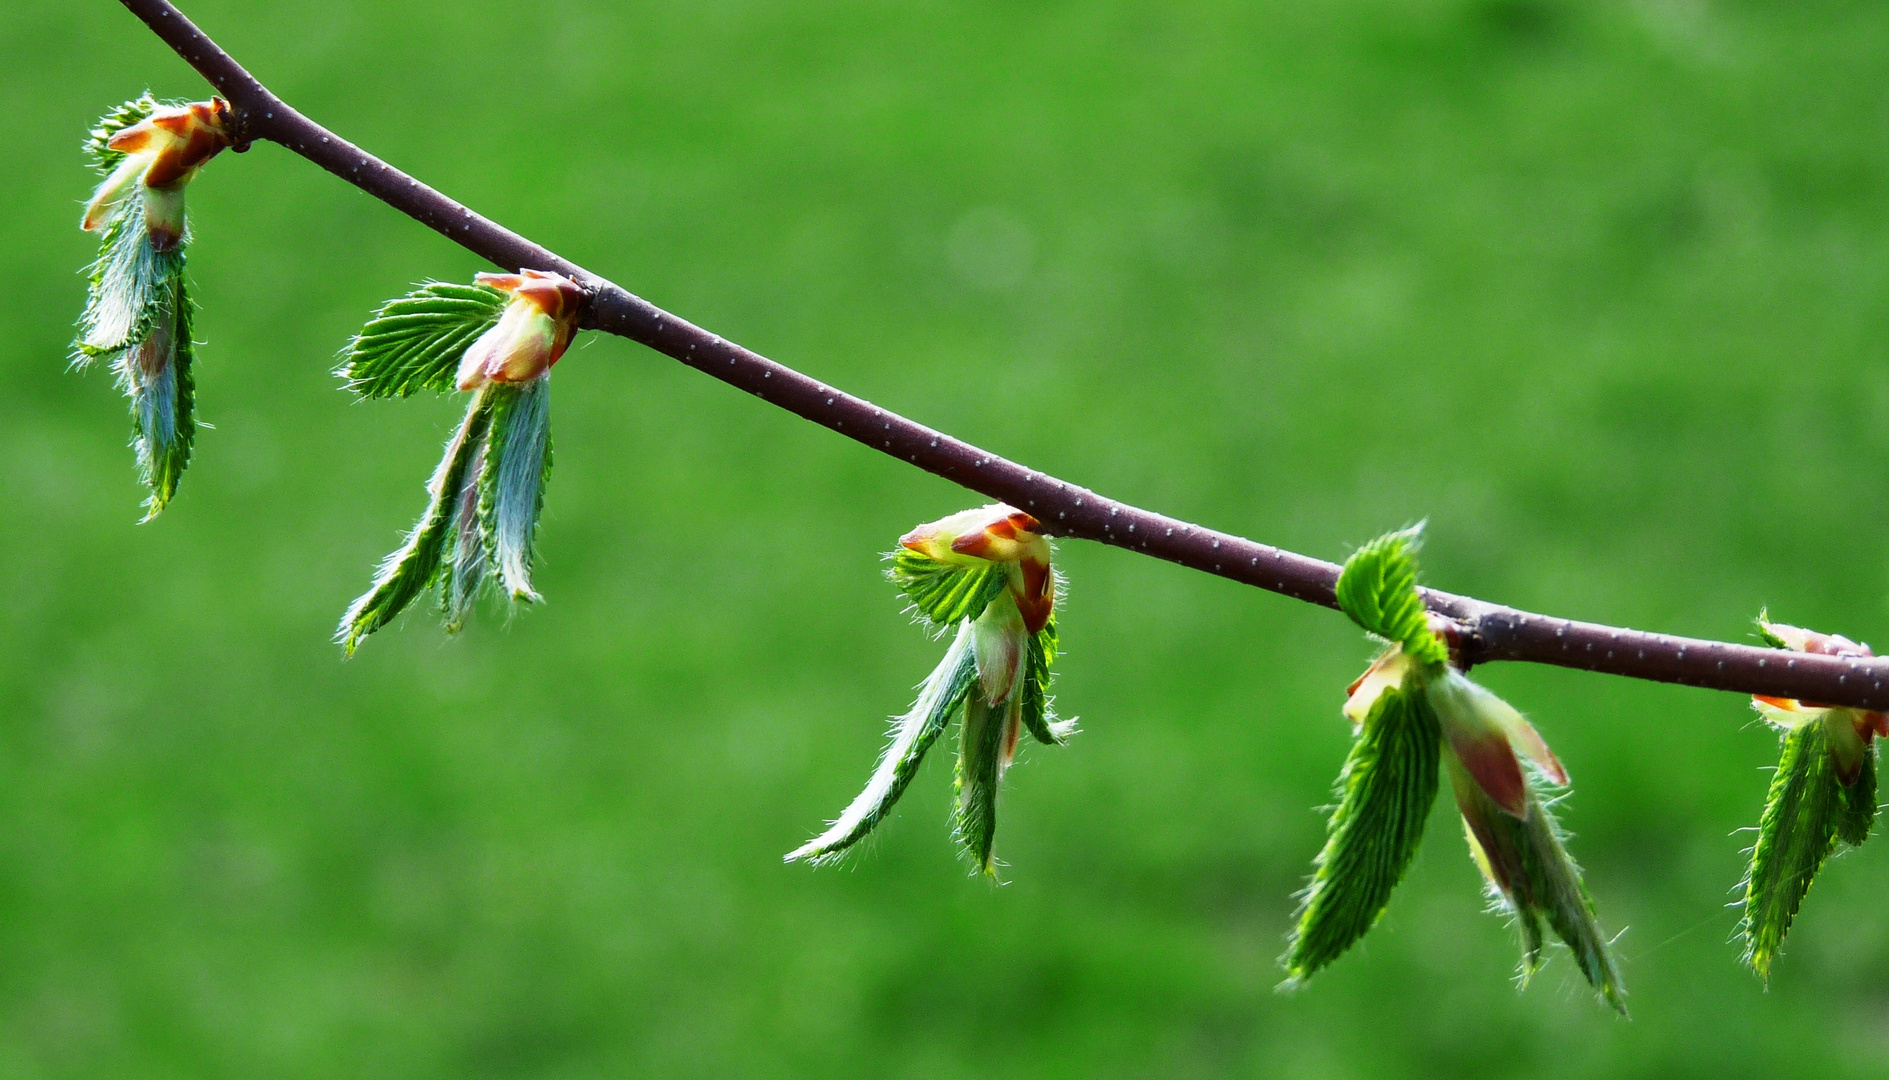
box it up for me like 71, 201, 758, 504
0, 0, 1889, 1078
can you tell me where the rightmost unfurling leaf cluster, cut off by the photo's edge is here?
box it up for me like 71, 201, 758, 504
1740, 614, 1889, 980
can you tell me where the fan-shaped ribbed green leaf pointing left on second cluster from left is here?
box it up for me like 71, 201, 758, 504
336, 281, 506, 398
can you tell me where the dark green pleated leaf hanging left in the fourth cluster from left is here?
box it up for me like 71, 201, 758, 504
1285, 687, 1439, 984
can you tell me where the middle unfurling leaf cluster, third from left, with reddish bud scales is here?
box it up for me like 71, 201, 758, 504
786, 504, 1075, 874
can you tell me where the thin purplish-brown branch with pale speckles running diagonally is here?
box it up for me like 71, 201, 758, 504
123, 0, 1889, 710
